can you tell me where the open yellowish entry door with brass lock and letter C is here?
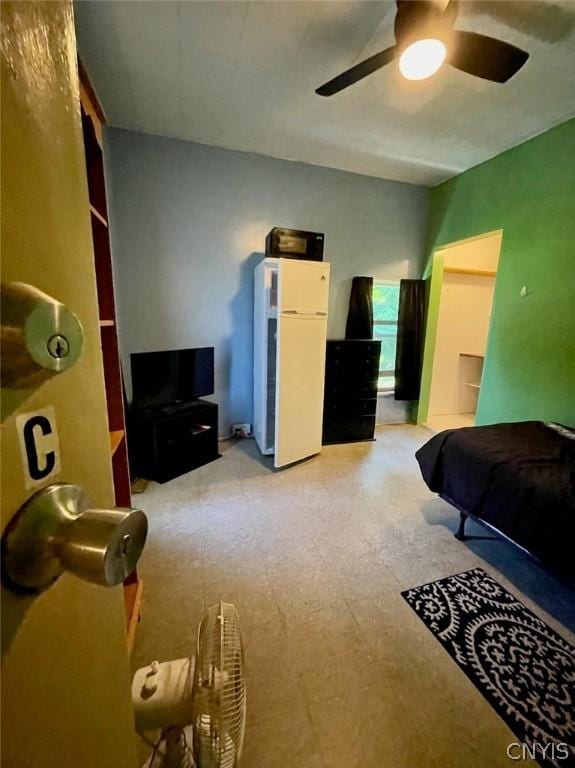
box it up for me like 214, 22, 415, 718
1, 2, 137, 768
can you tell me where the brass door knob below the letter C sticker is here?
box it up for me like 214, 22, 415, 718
2, 483, 148, 592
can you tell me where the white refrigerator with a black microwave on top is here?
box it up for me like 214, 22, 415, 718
254, 258, 329, 467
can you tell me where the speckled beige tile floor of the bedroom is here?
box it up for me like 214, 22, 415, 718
132, 426, 575, 768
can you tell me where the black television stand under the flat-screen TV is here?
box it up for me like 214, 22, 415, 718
128, 399, 220, 483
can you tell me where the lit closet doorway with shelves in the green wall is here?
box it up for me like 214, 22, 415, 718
425, 231, 502, 432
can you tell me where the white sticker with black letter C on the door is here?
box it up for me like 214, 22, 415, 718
16, 406, 60, 489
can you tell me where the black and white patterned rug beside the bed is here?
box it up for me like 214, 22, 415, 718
402, 568, 575, 768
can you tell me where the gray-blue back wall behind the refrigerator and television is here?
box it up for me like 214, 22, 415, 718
106, 129, 428, 435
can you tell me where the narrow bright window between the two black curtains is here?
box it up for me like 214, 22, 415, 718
373, 282, 399, 392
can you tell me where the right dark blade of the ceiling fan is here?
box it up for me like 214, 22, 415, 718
449, 30, 529, 83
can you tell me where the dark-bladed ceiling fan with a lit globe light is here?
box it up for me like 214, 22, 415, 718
316, 0, 529, 96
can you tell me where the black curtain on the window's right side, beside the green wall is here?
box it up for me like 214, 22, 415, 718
395, 280, 426, 400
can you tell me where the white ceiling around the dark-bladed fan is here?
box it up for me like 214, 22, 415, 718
76, 0, 575, 185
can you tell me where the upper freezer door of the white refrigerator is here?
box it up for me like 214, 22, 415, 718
278, 259, 329, 317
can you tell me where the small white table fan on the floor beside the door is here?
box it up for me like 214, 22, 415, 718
132, 602, 246, 768
